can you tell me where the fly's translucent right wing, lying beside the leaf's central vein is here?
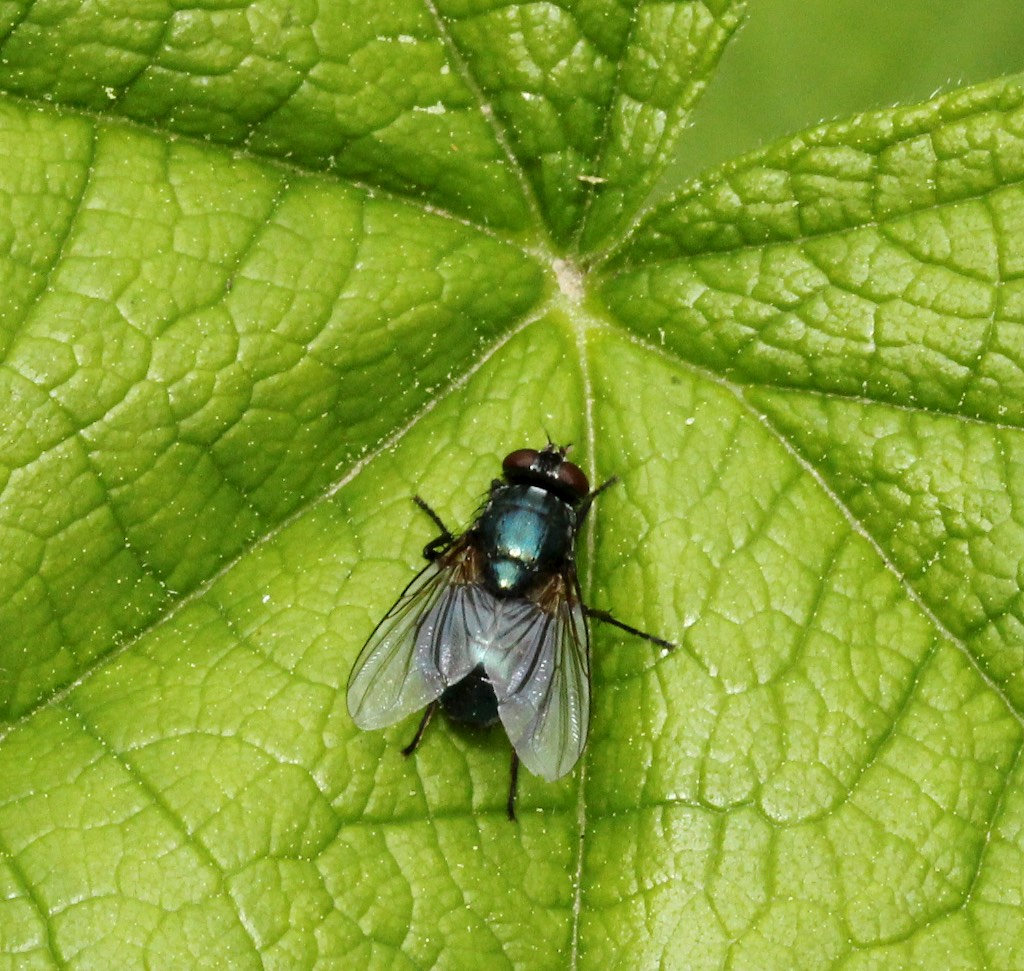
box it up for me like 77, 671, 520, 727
483, 576, 590, 782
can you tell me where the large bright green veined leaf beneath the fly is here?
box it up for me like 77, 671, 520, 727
0, 0, 1024, 971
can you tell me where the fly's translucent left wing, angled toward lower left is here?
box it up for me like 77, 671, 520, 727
348, 545, 490, 728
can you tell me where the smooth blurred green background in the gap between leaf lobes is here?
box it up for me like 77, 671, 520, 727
666, 0, 1024, 184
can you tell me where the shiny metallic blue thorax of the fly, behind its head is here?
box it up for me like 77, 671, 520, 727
476, 484, 577, 597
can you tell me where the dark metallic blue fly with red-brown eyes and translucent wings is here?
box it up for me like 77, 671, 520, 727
348, 442, 674, 819
